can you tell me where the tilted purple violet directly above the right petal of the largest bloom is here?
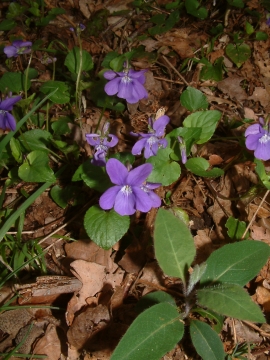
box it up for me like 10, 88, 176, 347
131, 115, 170, 159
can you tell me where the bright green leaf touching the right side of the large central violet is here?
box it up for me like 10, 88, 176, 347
146, 148, 181, 186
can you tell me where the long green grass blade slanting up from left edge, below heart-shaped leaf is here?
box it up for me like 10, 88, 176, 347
0, 165, 67, 242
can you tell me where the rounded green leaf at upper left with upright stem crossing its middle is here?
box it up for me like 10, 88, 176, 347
64, 46, 94, 74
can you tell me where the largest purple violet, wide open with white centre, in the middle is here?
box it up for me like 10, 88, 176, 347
99, 159, 159, 216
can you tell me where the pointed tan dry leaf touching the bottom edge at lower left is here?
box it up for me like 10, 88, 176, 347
33, 324, 61, 360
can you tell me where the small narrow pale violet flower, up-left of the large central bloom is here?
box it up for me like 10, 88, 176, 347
85, 122, 118, 166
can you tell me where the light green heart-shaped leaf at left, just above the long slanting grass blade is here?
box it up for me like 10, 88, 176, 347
18, 150, 56, 182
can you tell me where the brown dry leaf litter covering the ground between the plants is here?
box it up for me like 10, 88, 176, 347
0, 0, 270, 360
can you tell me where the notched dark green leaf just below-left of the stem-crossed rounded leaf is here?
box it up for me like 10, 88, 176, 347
40, 80, 70, 104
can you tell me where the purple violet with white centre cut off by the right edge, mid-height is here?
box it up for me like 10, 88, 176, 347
245, 117, 270, 161
